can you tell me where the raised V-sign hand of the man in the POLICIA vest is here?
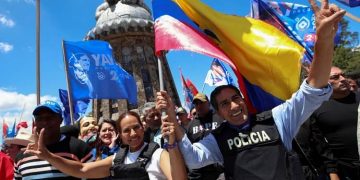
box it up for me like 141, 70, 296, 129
309, 0, 346, 39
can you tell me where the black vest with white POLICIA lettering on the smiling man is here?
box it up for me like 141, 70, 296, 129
212, 111, 304, 180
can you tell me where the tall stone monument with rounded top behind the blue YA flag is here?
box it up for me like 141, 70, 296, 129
87, 0, 180, 120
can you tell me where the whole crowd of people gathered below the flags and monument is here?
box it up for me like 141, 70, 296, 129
0, 0, 360, 180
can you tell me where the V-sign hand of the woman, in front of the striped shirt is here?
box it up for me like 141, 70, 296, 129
24, 127, 50, 159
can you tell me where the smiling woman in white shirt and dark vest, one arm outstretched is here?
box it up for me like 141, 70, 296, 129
25, 112, 187, 180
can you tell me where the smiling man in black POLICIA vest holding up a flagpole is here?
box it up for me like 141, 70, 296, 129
157, 0, 345, 180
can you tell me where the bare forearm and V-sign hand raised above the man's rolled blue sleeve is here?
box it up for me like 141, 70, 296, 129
307, 0, 346, 88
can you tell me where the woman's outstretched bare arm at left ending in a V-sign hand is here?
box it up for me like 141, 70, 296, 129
25, 129, 112, 178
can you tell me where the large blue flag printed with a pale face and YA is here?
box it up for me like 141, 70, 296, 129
64, 40, 137, 105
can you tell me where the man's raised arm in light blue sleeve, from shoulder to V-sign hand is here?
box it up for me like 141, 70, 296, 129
272, 0, 345, 150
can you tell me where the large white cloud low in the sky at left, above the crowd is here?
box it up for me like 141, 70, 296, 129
0, 88, 58, 125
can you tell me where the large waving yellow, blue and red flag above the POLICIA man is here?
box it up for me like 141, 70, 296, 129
153, 0, 305, 113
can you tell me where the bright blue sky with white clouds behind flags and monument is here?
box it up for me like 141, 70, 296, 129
0, 0, 360, 127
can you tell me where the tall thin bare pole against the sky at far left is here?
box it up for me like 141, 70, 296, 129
36, 0, 40, 105
